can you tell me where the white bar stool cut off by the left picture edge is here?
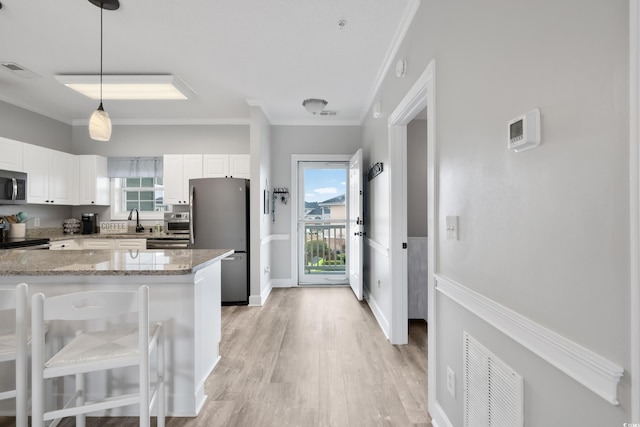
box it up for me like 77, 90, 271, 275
0, 283, 29, 427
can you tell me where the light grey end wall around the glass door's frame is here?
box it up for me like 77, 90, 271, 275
269, 126, 362, 286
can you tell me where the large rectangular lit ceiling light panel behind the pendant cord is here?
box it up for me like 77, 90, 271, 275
56, 74, 193, 100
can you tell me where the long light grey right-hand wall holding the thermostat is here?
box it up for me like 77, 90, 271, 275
363, 0, 640, 426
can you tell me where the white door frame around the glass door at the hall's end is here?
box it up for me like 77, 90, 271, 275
289, 154, 353, 287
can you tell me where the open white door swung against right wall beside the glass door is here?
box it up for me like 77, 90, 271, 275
347, 149, 364, 300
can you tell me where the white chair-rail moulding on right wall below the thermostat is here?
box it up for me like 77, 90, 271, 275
435, 274, 624, 405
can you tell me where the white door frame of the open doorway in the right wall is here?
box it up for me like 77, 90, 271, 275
388, 59, 439, 408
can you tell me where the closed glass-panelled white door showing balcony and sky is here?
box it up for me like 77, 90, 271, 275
297, 162, 349, 285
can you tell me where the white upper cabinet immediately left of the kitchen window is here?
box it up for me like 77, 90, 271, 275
77, 155, 110, 205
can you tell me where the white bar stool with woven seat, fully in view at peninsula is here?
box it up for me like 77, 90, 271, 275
31, 286, 165, 427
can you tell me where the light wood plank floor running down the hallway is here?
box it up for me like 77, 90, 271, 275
0, 287, 431, 427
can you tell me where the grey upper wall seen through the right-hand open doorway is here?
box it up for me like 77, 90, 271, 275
407, 120, 427, 237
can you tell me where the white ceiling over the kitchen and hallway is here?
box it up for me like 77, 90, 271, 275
0, 0, 417, 125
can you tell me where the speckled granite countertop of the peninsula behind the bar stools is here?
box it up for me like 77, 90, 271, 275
0, 249, 233, 276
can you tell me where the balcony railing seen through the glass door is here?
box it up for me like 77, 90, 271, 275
304, 223, 347, 274
